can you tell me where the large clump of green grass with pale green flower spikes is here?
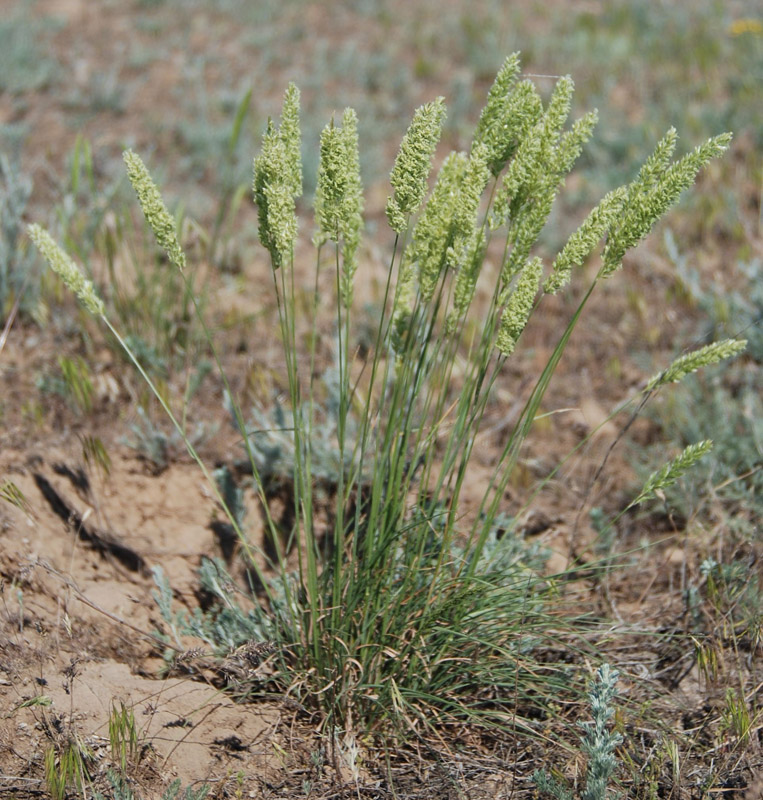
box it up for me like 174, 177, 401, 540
30, 54, 744, 736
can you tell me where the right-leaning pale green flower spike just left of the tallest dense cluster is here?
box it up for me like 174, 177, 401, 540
387, 97, 445, 233
